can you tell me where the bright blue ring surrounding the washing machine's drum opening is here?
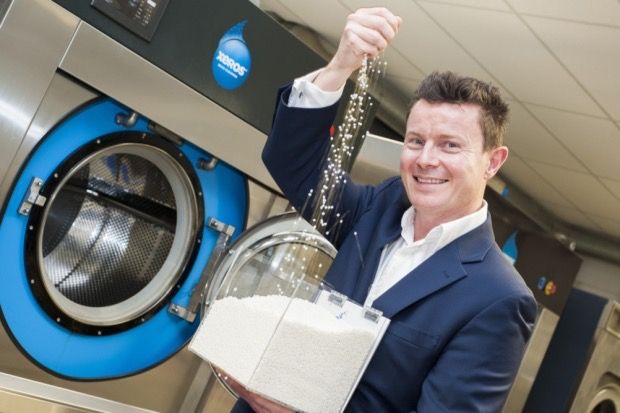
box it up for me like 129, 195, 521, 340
0, 99, 248, 380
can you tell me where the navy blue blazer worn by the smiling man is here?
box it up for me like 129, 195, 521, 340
233, 88, 537, 413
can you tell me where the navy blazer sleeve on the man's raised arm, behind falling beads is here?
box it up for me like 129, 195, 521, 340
262, 85, 375, 247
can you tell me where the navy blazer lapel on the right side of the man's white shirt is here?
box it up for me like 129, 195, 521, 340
373, 217, 493, 318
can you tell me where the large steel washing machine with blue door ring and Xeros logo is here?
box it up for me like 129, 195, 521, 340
0, 0, 330, 412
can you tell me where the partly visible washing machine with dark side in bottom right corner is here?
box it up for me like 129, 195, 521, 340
524, 289, 620, 413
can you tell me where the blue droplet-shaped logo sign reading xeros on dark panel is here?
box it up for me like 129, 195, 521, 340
211, 20, 252, 90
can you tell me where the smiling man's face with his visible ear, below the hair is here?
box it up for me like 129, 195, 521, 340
400, 100, 508, 225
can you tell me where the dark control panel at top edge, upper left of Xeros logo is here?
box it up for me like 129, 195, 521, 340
91, 0, 169, 41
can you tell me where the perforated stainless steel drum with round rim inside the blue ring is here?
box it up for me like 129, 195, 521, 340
27, 137, 202, 331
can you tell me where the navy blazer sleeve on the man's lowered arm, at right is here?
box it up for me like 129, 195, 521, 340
417, 294, 537, 413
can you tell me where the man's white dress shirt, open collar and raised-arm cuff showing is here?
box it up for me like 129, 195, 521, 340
288, 69, 488, 306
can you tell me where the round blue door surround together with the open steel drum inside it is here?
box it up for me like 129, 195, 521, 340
0, 99, 248, 380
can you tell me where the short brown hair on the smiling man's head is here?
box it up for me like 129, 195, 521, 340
408, 71, 508, 151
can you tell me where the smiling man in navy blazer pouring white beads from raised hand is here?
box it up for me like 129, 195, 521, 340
233, 8, 536, 413
